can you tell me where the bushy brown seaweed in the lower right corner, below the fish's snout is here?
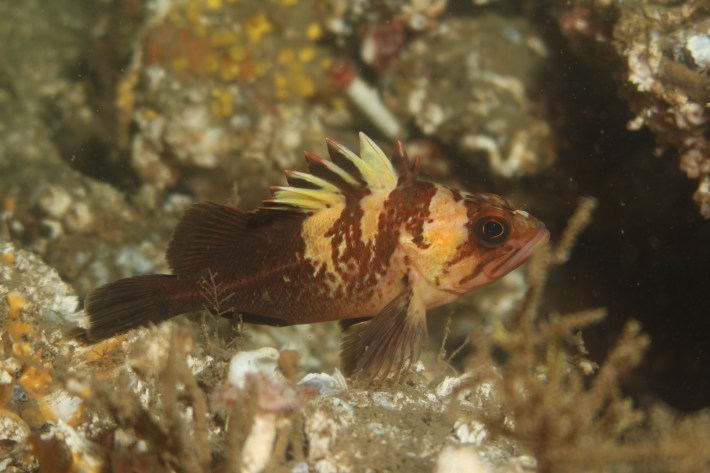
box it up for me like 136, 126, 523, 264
450, 199, 710, 473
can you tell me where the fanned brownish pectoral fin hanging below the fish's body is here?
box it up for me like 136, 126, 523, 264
340, 285, 427, 378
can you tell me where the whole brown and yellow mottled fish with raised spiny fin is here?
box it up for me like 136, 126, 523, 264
82, 133, 549, 379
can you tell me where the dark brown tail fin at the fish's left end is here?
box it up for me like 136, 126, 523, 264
79, 274, 182, 342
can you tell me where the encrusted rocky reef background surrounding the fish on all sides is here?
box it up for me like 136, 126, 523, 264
0, 0, 710, 473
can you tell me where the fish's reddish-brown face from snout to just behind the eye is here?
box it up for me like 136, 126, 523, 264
444, 194, 550, 293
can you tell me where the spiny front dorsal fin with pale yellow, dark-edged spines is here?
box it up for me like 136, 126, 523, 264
264, 133, 418, 212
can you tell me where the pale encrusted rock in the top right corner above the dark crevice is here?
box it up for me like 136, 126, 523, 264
554, 1, 710, 218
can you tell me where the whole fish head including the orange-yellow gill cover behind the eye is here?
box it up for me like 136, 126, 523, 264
404, 186, 550, 300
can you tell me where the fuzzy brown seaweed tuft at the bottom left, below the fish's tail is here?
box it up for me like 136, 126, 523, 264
93, 330, 211, 473
